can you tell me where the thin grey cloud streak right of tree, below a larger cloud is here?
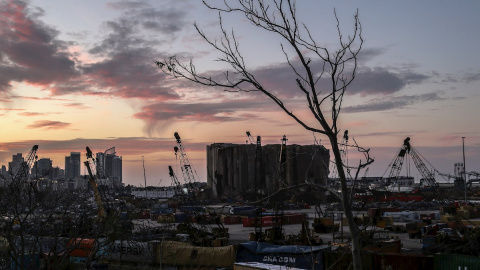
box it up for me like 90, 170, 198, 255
342, 93, 442, 113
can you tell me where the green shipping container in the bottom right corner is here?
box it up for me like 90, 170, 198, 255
434, 254, 480, 270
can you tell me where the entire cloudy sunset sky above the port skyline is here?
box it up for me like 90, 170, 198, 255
0, 0, 480, 186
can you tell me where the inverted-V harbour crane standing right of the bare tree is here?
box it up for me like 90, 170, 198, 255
388, 137, 438, 187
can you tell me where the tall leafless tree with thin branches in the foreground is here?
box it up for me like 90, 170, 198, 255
156, 0, 373, 269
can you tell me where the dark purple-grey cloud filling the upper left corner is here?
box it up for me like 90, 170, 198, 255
0, 0, 77, 92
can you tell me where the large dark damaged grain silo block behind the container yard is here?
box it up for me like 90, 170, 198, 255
207, 137, 330, 200
